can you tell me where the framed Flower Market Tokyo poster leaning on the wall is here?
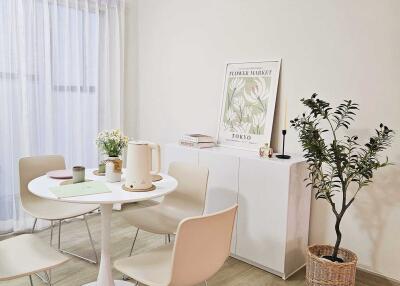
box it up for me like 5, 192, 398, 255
218, 59, 281, 150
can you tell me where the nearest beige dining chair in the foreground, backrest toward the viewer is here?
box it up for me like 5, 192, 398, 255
114, 205, 237, 286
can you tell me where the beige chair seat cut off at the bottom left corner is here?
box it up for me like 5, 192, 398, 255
0, 234, 69, 286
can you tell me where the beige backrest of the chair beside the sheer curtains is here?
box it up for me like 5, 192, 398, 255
19, 155, 65, 206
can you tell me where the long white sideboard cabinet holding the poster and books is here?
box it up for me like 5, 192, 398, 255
163, 144, 311, 279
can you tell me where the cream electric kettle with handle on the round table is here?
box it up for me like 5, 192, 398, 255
125, 141, 161, 190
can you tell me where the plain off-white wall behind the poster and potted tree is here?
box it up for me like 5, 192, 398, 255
126, 0, 400, 280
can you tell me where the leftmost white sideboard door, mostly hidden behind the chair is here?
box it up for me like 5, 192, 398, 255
161, 144, 199, 173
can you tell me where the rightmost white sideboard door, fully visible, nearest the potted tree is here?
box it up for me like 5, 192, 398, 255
236, 158, 289, 273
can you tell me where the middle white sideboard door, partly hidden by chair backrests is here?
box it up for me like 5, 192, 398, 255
199, 151, 239, 253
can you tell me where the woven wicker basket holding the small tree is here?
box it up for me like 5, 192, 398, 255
306, 245, 357, 286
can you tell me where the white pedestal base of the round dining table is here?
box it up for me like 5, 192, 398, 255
84, 204, 133, 286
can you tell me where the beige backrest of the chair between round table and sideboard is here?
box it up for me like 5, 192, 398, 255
162, 162, 208, 216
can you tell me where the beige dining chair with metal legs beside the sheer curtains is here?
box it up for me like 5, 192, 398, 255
19, 155, 99, 264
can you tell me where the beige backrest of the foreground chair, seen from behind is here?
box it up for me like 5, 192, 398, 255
169, 205, 237, 286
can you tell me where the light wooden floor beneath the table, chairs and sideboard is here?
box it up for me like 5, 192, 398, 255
0, 205, 397, 286
